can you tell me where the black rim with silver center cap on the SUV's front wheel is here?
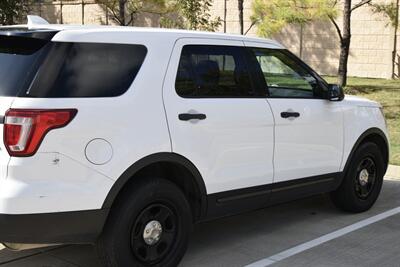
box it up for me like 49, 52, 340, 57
355, 157, 376, 200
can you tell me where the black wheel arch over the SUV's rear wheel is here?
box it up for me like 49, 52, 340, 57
102, 152, 207, 221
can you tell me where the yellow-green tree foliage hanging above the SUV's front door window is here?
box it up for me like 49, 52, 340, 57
251, 0, 338, 37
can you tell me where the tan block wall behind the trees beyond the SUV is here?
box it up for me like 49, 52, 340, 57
28, 0, 400, 78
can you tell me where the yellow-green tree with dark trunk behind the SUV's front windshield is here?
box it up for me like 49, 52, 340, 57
251, 0, 386, 86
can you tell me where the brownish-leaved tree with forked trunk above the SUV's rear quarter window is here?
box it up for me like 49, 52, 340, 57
97, 0, 166, 26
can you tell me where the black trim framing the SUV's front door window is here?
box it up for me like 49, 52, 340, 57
246, 46, 328, 100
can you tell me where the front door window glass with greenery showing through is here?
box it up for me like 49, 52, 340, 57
252, 48, 321, 98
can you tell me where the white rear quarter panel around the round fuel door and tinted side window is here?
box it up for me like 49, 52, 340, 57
12, 31, 174, 183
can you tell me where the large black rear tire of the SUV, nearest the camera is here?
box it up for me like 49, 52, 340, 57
96, 178, 192, 267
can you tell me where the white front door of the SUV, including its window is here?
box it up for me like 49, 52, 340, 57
246, 42, 343, 183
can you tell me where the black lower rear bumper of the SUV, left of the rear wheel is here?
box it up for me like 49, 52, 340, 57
0, 209, 109, 244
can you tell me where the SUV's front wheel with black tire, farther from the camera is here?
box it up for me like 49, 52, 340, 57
331, 142, 385, 212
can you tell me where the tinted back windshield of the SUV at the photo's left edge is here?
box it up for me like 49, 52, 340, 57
0, 36, 46, 96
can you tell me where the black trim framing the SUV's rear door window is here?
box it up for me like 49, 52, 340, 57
174, 44, 265, 99
